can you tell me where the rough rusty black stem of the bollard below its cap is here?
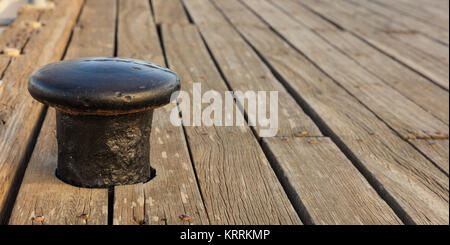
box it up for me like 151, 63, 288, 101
56, 111, 155, 188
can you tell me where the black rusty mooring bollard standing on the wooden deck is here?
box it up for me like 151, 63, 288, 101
28, 58, 180, 188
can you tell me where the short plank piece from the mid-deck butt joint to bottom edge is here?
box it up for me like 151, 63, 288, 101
263, 138, 401, 225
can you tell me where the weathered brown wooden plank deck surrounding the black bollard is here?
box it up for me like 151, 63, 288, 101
0, 0, 449, 225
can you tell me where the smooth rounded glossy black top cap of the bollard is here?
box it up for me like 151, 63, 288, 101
28, 57, 180, 116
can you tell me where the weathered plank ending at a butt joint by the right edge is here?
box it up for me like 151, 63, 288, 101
244, 0, 449, 139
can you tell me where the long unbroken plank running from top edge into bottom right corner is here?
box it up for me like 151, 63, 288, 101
212, 1, 448, 223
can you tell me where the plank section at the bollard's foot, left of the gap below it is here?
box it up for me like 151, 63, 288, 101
9, 108, 108, 225
